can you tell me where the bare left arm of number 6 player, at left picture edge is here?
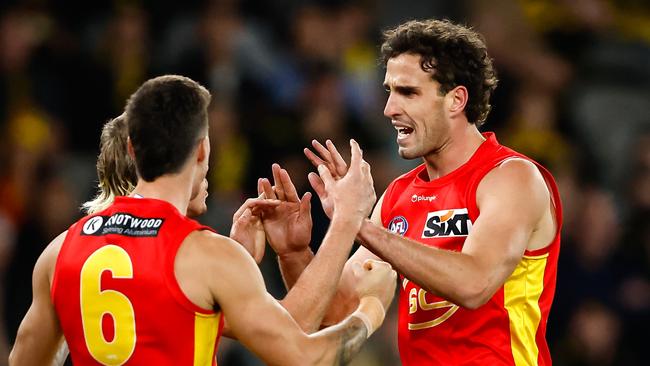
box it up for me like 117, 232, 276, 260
9, 232, 66, 366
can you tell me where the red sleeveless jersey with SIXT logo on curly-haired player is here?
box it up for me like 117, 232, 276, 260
381, 133, 562, 366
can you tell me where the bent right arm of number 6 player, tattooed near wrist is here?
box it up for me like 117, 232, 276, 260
185, 233, 392, 365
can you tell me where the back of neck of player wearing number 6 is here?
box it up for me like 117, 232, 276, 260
131, 172, 192, 215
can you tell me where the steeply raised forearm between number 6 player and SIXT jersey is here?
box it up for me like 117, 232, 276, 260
281, 218, 359, 333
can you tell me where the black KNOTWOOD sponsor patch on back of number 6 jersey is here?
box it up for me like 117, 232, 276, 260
81, 213, 165, 236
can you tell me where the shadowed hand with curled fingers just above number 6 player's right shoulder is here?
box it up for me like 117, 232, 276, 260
230, 197, 280, 263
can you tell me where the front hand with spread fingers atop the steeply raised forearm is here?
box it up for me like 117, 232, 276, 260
308, 140, 377, 220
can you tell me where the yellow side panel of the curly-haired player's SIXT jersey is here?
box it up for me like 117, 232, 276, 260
503, 254, 548, 366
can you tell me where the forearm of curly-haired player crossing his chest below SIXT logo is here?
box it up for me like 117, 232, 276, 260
358, 220, 489, 308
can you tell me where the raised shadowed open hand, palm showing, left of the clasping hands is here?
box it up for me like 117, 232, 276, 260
257, 164, 312, 255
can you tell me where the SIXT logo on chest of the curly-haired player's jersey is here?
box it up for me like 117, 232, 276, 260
422, 208, 472, 238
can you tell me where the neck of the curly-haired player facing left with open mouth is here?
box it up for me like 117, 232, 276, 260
423, 124, 485, 180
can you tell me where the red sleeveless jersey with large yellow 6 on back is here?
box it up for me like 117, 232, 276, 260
51, 197, 223, 366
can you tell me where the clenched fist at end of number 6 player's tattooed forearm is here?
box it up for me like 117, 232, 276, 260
352, 259, 397, 310
